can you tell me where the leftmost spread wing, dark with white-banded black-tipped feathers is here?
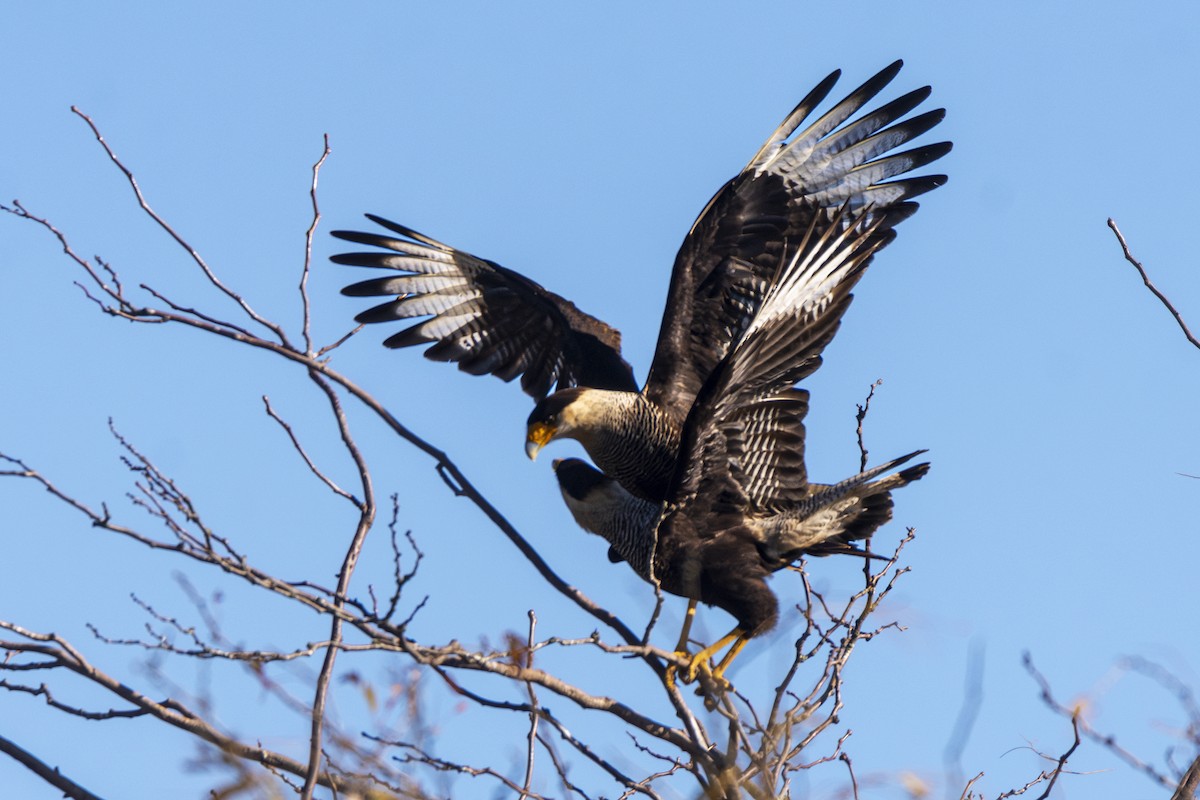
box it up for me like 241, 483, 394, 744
331, 213, 637, 399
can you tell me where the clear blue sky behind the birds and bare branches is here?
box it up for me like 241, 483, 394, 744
0, 2, 1200, 799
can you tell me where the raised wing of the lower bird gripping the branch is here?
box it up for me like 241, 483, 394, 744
668, 209, 890, 513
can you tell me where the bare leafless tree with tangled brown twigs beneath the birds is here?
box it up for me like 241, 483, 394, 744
0, 109, 1200, 799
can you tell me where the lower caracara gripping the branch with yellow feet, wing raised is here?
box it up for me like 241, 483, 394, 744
554, 211, 929, 680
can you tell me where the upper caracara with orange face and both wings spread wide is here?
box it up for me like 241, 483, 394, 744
332, 61, 950, 503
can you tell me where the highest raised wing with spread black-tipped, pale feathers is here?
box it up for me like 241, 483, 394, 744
643, 61, 950, 425
